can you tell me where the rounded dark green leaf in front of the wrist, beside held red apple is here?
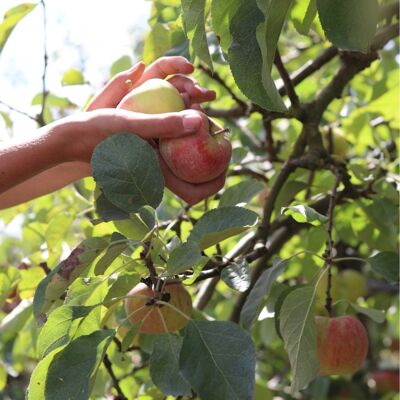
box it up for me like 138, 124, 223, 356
91, 132, 164, 213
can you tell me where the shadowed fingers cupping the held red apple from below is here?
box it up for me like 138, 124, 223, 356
159, 155, 225, 205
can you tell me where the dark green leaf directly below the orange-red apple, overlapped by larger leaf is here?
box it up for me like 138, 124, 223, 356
150, 334, 192, 396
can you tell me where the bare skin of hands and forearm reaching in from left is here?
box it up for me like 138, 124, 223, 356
0, 57, 225, 209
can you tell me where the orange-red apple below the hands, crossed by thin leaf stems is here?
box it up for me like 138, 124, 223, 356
125, 282, 192, 334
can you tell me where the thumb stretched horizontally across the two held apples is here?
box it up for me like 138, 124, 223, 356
93, 109, 208, 139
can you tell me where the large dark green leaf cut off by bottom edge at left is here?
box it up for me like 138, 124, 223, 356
44, 330, 114, 400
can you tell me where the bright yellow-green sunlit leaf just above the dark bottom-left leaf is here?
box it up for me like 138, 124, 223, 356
37, 305, 97, 358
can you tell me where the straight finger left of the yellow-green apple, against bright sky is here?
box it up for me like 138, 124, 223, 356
86, 62, 145, 111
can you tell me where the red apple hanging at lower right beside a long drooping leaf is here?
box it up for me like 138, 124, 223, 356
315, 315, 368, 376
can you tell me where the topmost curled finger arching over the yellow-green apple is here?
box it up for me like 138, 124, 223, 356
134, 56, 194, 87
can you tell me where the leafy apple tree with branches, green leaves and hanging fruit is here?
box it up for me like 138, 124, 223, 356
0, 0, 400, 400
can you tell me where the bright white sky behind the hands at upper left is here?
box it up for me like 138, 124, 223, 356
0, 0, 151, 134
